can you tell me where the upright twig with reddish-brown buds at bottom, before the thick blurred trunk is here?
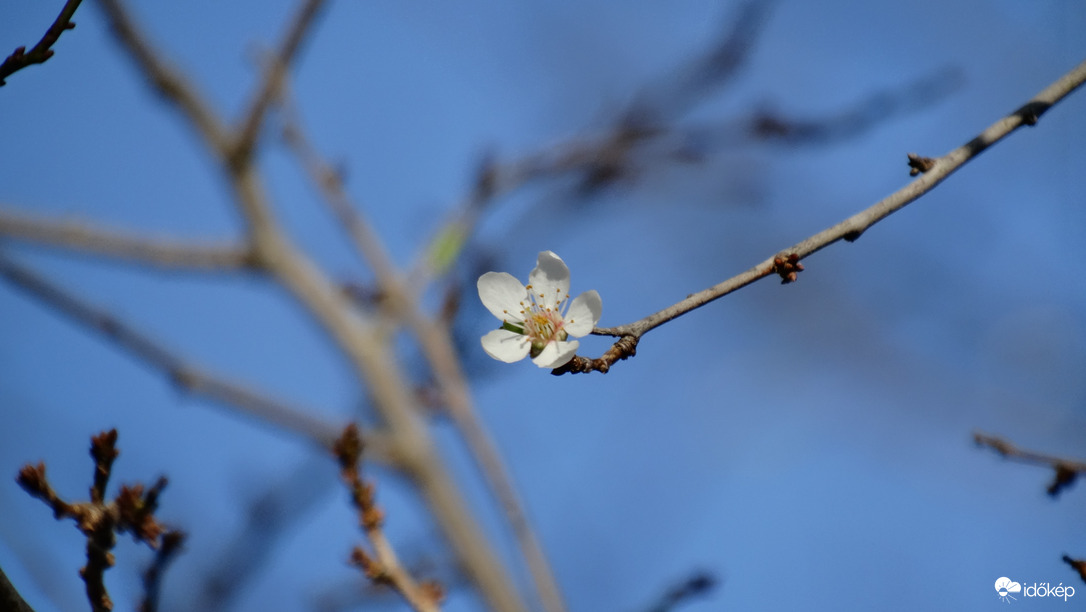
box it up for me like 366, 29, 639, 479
333, 423, 444, 612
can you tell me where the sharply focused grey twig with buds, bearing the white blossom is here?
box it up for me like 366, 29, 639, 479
553, 56, 1086, 374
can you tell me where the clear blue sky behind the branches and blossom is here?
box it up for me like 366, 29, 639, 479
0, 0, 1086, 612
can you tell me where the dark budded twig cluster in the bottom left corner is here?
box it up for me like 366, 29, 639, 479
16, 430, 174, 612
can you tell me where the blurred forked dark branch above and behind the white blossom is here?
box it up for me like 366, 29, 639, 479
409, 9, 961, 292
